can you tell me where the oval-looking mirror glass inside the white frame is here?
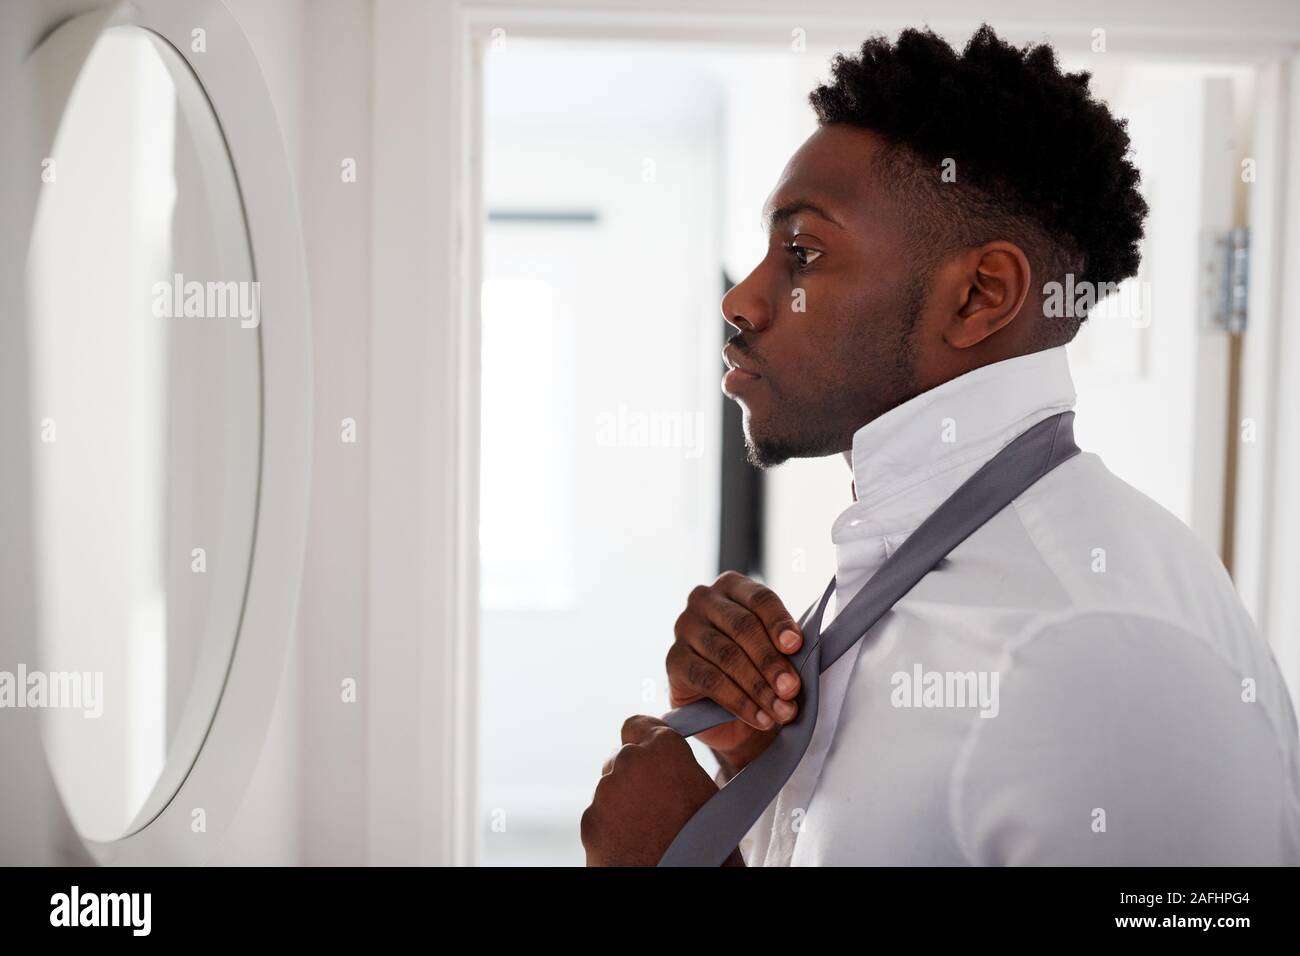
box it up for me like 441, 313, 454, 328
26, 26, 261, 842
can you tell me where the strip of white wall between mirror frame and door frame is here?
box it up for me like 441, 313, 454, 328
208, 0, 372, 865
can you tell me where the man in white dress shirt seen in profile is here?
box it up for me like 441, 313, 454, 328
581, 26, 1300, 866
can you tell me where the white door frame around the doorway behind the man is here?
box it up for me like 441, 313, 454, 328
369, 0, 1300, 864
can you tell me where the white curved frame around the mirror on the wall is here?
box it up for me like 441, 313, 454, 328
12, 0, 312, 865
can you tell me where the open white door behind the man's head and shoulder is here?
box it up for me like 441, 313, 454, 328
1069, 66, 1249, 554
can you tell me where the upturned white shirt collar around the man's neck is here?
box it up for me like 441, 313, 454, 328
832, 346, 1075, 533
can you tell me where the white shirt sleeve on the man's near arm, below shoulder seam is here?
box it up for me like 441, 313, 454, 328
949, 613, 1297, 866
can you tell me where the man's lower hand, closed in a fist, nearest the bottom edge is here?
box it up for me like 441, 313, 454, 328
580, 714, 744, 866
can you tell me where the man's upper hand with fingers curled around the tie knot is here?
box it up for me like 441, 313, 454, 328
667, 571, 803, 774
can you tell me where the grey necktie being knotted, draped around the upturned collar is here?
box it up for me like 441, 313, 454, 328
659, 411, 1079, 866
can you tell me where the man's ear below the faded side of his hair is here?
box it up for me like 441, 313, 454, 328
943, 239, 1032, 349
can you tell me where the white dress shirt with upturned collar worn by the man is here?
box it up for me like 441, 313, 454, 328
741, 347, 1300, 866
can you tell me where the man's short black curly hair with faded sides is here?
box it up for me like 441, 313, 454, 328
809, 23, 1148, 347
